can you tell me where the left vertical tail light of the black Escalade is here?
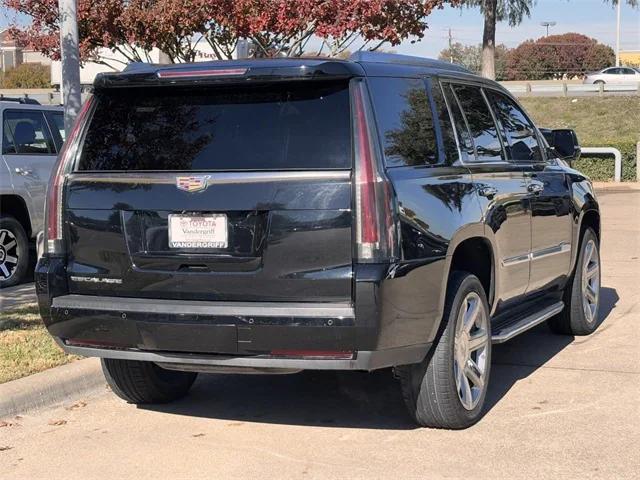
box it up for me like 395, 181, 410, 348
45, 97, 94, 255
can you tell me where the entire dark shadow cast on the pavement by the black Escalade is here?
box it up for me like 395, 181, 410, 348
138, 288, 618, 430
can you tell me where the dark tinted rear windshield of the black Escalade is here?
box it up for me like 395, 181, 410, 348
77, 82, 351, 170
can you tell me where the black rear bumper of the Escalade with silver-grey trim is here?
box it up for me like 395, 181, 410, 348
45, 295, 429, 373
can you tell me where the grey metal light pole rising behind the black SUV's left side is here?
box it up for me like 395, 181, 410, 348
58, 0, 82, 136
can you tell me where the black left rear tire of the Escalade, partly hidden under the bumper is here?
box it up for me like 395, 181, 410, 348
102, 358, 197, 404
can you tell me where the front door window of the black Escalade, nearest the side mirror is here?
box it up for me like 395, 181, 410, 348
485, 90, 543, 162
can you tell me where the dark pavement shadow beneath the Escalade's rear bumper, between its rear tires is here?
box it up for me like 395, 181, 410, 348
138, 369, 416, 430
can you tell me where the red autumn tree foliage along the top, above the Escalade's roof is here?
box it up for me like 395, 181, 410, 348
0, 0, 458, 67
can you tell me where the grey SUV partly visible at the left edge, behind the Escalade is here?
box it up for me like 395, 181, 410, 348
0, 97, 64, 288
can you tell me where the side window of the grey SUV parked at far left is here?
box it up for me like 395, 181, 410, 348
3, 110, 55, 155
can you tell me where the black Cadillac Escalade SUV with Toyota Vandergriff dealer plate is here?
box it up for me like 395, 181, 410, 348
36, 53, 600, 428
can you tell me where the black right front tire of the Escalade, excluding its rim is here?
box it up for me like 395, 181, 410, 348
548, 228, 601, 335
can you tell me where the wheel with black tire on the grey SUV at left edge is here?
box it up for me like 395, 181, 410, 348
0, 215, 29, 288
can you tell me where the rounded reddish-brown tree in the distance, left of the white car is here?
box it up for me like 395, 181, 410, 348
507, 33, 615, 80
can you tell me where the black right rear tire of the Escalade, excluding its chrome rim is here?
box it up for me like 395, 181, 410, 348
396, 272, 491, 429
